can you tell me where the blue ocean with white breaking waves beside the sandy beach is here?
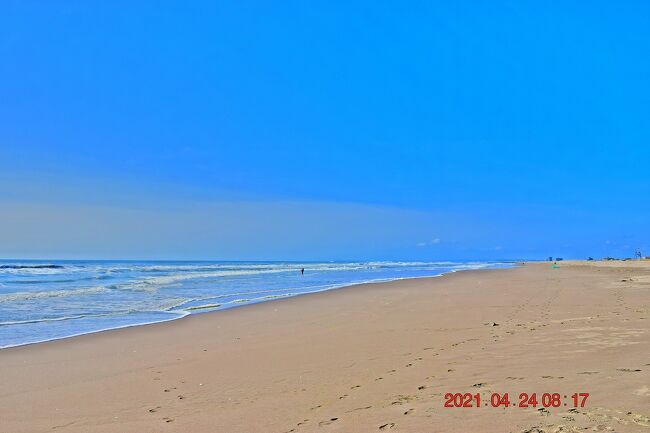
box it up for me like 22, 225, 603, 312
0, 260, 512, 348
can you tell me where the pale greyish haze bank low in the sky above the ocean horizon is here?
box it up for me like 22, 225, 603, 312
0, 201, 470, 260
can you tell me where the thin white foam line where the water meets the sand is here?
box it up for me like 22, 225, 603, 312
0, 261, 508, 354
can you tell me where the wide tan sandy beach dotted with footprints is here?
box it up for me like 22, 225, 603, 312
0, 262, 650, 433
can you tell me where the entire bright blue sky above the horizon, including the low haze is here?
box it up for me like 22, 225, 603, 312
0, 0, 650, 260
